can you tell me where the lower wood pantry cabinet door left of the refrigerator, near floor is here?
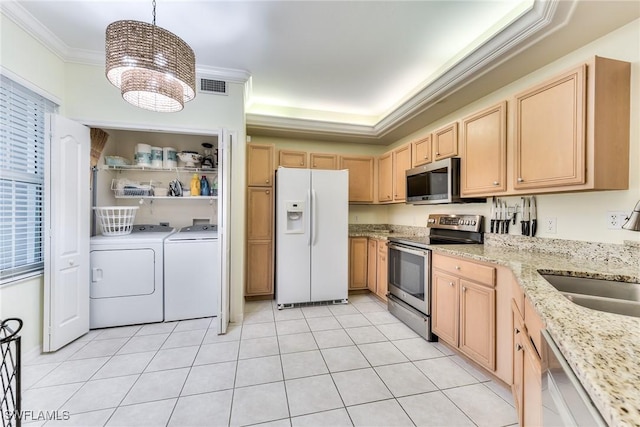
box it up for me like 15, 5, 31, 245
245, 240, 273, 296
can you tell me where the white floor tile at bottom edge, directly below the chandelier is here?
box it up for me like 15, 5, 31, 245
107, 399, 178, 427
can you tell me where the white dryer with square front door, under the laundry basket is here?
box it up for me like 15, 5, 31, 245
89, 225, 175, 329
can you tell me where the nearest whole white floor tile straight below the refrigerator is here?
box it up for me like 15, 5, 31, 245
285, 375, 343, 418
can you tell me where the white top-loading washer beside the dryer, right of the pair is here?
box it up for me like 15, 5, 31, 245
164, 224, 220, 321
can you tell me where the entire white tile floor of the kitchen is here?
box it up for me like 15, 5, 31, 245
23, 295, 517, 427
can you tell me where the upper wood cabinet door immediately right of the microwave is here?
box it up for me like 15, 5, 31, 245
461, 102, 507, 196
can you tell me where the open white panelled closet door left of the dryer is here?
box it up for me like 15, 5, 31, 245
42, 115, 91, 352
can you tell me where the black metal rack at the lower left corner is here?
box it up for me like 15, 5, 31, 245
0, 318, 22, 427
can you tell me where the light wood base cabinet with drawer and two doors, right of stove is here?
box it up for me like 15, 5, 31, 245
431, 254, 496, 371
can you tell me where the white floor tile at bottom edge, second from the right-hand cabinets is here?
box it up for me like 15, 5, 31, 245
398, 391, 474, 427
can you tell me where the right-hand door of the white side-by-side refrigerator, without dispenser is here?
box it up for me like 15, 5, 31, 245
311, 169, 349, 301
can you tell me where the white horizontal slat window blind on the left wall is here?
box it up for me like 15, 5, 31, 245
0, 75, 56, 284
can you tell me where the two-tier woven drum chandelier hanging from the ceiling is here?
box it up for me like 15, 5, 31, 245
105, 0, 196, 112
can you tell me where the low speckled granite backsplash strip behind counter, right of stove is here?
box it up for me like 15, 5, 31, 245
484, 233, 640, 266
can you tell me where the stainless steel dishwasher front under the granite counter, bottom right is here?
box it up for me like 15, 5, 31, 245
542, 330, 607, 427
